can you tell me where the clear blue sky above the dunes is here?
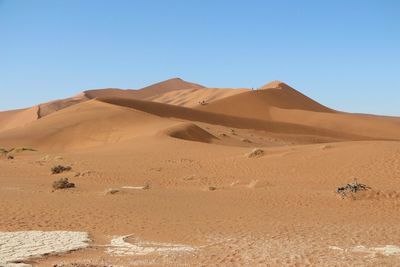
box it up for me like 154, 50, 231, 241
0, 0, 400, 115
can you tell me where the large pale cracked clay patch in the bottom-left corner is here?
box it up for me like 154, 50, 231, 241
0, 231, 90, 266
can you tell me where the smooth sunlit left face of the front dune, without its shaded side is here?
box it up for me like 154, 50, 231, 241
0, 100, 172, 150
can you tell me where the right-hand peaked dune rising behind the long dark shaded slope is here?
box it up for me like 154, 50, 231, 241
193, 81, 400, 140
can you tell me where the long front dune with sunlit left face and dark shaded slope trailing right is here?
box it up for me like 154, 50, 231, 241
0, 98, 350, 150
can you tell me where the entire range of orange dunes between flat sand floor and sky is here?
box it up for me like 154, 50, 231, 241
0, 78, 400, 149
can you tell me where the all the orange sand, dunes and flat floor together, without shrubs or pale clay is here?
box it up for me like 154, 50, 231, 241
0, 79, 400, 266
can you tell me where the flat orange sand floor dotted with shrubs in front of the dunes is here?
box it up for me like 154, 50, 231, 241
0, 137, 400, 266
